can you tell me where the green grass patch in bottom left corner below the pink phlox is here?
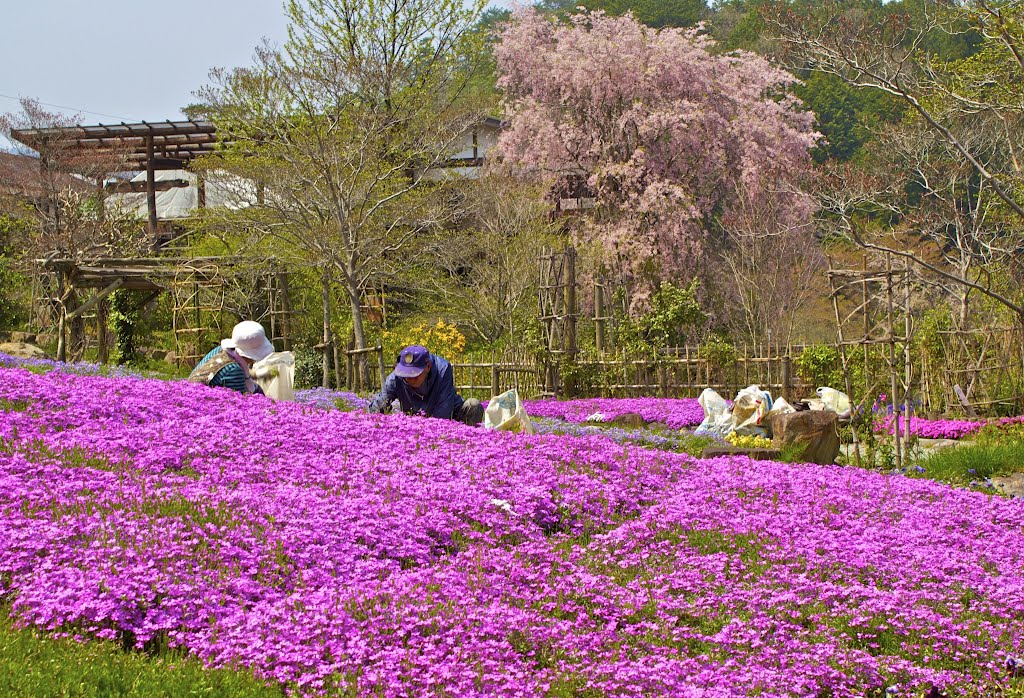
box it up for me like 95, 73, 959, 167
0, 609, 282, 698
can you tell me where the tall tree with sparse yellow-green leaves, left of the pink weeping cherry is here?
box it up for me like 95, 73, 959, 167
200, 0, 485, 356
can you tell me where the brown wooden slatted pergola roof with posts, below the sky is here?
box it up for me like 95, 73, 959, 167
10, 120, 225, 236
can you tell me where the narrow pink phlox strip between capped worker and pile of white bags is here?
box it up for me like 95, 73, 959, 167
523, 397, 703, 429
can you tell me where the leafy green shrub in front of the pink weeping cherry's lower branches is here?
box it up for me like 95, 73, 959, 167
618, 279, 708, 351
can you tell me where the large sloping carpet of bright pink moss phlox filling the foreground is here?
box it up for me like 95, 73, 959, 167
0, 368, 1024, 696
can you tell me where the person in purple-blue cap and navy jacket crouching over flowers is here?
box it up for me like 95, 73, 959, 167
367, 345, 483, 425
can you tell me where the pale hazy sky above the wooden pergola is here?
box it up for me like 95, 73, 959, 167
0, 0, 286, 124
